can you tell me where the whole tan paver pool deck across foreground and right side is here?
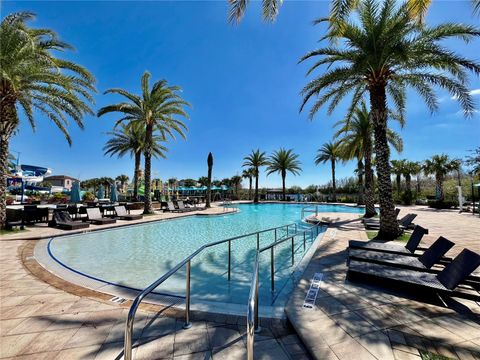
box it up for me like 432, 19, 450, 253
0, 204, 480, 360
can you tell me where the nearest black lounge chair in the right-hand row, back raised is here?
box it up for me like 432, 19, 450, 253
348, 249, 480, 301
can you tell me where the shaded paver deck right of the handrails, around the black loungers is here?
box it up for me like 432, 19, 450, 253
286, 207, 480, 360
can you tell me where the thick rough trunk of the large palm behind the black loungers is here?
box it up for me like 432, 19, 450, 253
369, 84, 401, 240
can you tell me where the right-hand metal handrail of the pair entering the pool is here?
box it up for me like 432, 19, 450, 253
247, 224, 321, 360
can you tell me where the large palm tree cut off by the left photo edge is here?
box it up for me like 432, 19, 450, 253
0, 12, 95, 228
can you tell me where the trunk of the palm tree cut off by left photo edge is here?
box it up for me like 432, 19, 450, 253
0, 98, 18, 229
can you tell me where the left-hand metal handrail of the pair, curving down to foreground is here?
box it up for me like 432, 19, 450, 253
123, 223, 297, 360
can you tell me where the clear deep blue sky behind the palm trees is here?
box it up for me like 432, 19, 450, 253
1, 1, 480, 186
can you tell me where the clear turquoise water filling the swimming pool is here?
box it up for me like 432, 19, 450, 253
49, 204, 362, 305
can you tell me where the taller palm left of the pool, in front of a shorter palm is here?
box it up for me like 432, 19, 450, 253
98, 71, 190, 214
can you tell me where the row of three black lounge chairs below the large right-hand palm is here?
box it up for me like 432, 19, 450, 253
347, 225, 480, 301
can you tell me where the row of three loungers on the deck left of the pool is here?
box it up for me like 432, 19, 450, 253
49, 206, 143, 230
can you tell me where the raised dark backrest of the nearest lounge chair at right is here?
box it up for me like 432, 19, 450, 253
437, 249, 480, 290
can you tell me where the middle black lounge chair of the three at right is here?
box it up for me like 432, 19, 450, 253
348, 236, 455, 271
